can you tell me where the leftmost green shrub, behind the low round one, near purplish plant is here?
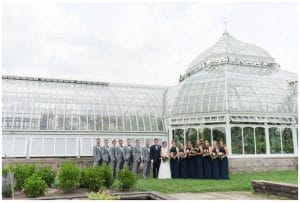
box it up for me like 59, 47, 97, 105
11, 164, 35, 190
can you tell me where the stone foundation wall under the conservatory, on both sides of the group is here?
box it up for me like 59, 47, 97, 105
2, 157, 298, 173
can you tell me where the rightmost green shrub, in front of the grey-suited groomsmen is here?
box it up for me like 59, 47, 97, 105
118, 167, 137, 191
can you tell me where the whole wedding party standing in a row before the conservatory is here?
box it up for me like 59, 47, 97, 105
93, 138, 229, 179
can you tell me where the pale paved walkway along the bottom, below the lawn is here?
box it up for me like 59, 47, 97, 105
165, 191, 286, 200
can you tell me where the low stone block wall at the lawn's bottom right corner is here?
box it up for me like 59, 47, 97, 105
251, 180, 298, 200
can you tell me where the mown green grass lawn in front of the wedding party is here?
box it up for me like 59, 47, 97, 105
137, 170, 298, 193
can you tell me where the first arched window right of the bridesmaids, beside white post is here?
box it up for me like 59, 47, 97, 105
231, 127, 243, 154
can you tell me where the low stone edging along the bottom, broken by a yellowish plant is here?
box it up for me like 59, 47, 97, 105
30, 191, 174, 200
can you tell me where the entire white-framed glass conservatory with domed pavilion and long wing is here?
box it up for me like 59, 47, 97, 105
2, 32, 298, 162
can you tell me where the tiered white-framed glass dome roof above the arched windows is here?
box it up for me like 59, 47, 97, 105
165, 33, 297, 117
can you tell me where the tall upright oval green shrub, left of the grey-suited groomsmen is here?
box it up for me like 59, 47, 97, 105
58, 162, 80, 193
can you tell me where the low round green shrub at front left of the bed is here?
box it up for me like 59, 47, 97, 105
24, 174, 48, 197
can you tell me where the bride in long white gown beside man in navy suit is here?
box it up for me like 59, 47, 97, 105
158, 142, 171, 179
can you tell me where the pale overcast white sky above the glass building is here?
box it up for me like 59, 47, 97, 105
2, 1, 299, 86
